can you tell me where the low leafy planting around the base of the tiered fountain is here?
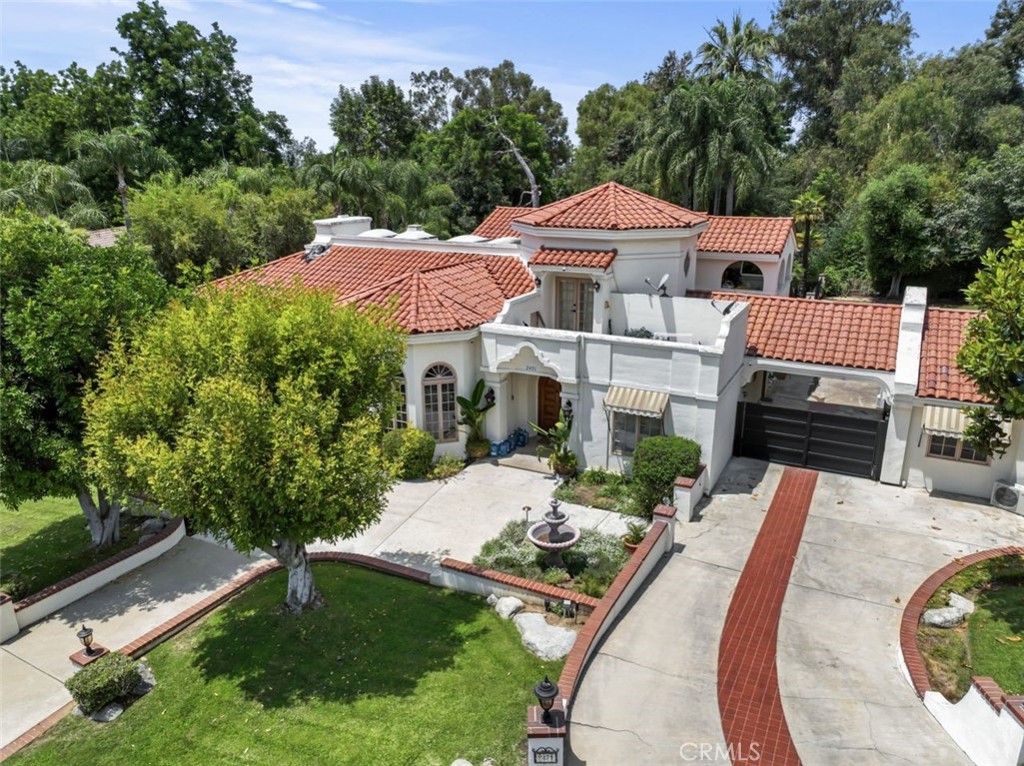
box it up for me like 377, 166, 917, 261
473, 521, 630, 598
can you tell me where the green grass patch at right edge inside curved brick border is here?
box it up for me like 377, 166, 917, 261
967, 583, 1024, 694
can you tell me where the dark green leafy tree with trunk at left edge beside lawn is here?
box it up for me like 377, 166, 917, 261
0, 209, 167, 546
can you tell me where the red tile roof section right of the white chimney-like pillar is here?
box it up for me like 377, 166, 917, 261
918, 308, 989, 403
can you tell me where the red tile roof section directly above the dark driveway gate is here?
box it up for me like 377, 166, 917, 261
711, 291, 901, 372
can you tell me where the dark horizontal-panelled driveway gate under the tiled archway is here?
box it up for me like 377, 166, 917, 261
733, 401, 887, 479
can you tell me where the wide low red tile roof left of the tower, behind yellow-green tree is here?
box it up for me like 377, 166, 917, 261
221, 246, 534, 333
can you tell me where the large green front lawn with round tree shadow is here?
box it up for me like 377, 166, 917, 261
10, 564, 561, 766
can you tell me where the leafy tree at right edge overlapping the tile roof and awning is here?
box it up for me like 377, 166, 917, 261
956, 221, 1024, 455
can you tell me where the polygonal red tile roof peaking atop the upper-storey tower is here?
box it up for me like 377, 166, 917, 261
515, 181, 708, 231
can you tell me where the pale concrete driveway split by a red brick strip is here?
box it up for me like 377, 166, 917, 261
570, 459, 1024, 766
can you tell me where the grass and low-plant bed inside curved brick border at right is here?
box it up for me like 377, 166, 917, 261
918, 556, 1024, 701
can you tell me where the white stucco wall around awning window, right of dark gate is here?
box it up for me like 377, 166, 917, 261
904, 406, 1024, 500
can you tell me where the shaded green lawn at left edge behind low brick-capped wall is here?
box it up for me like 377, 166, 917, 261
0, 498, 138, 599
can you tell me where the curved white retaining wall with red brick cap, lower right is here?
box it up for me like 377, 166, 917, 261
899, 546, 1024, 766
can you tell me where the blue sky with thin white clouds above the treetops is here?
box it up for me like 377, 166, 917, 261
0, 0, 997, 150
